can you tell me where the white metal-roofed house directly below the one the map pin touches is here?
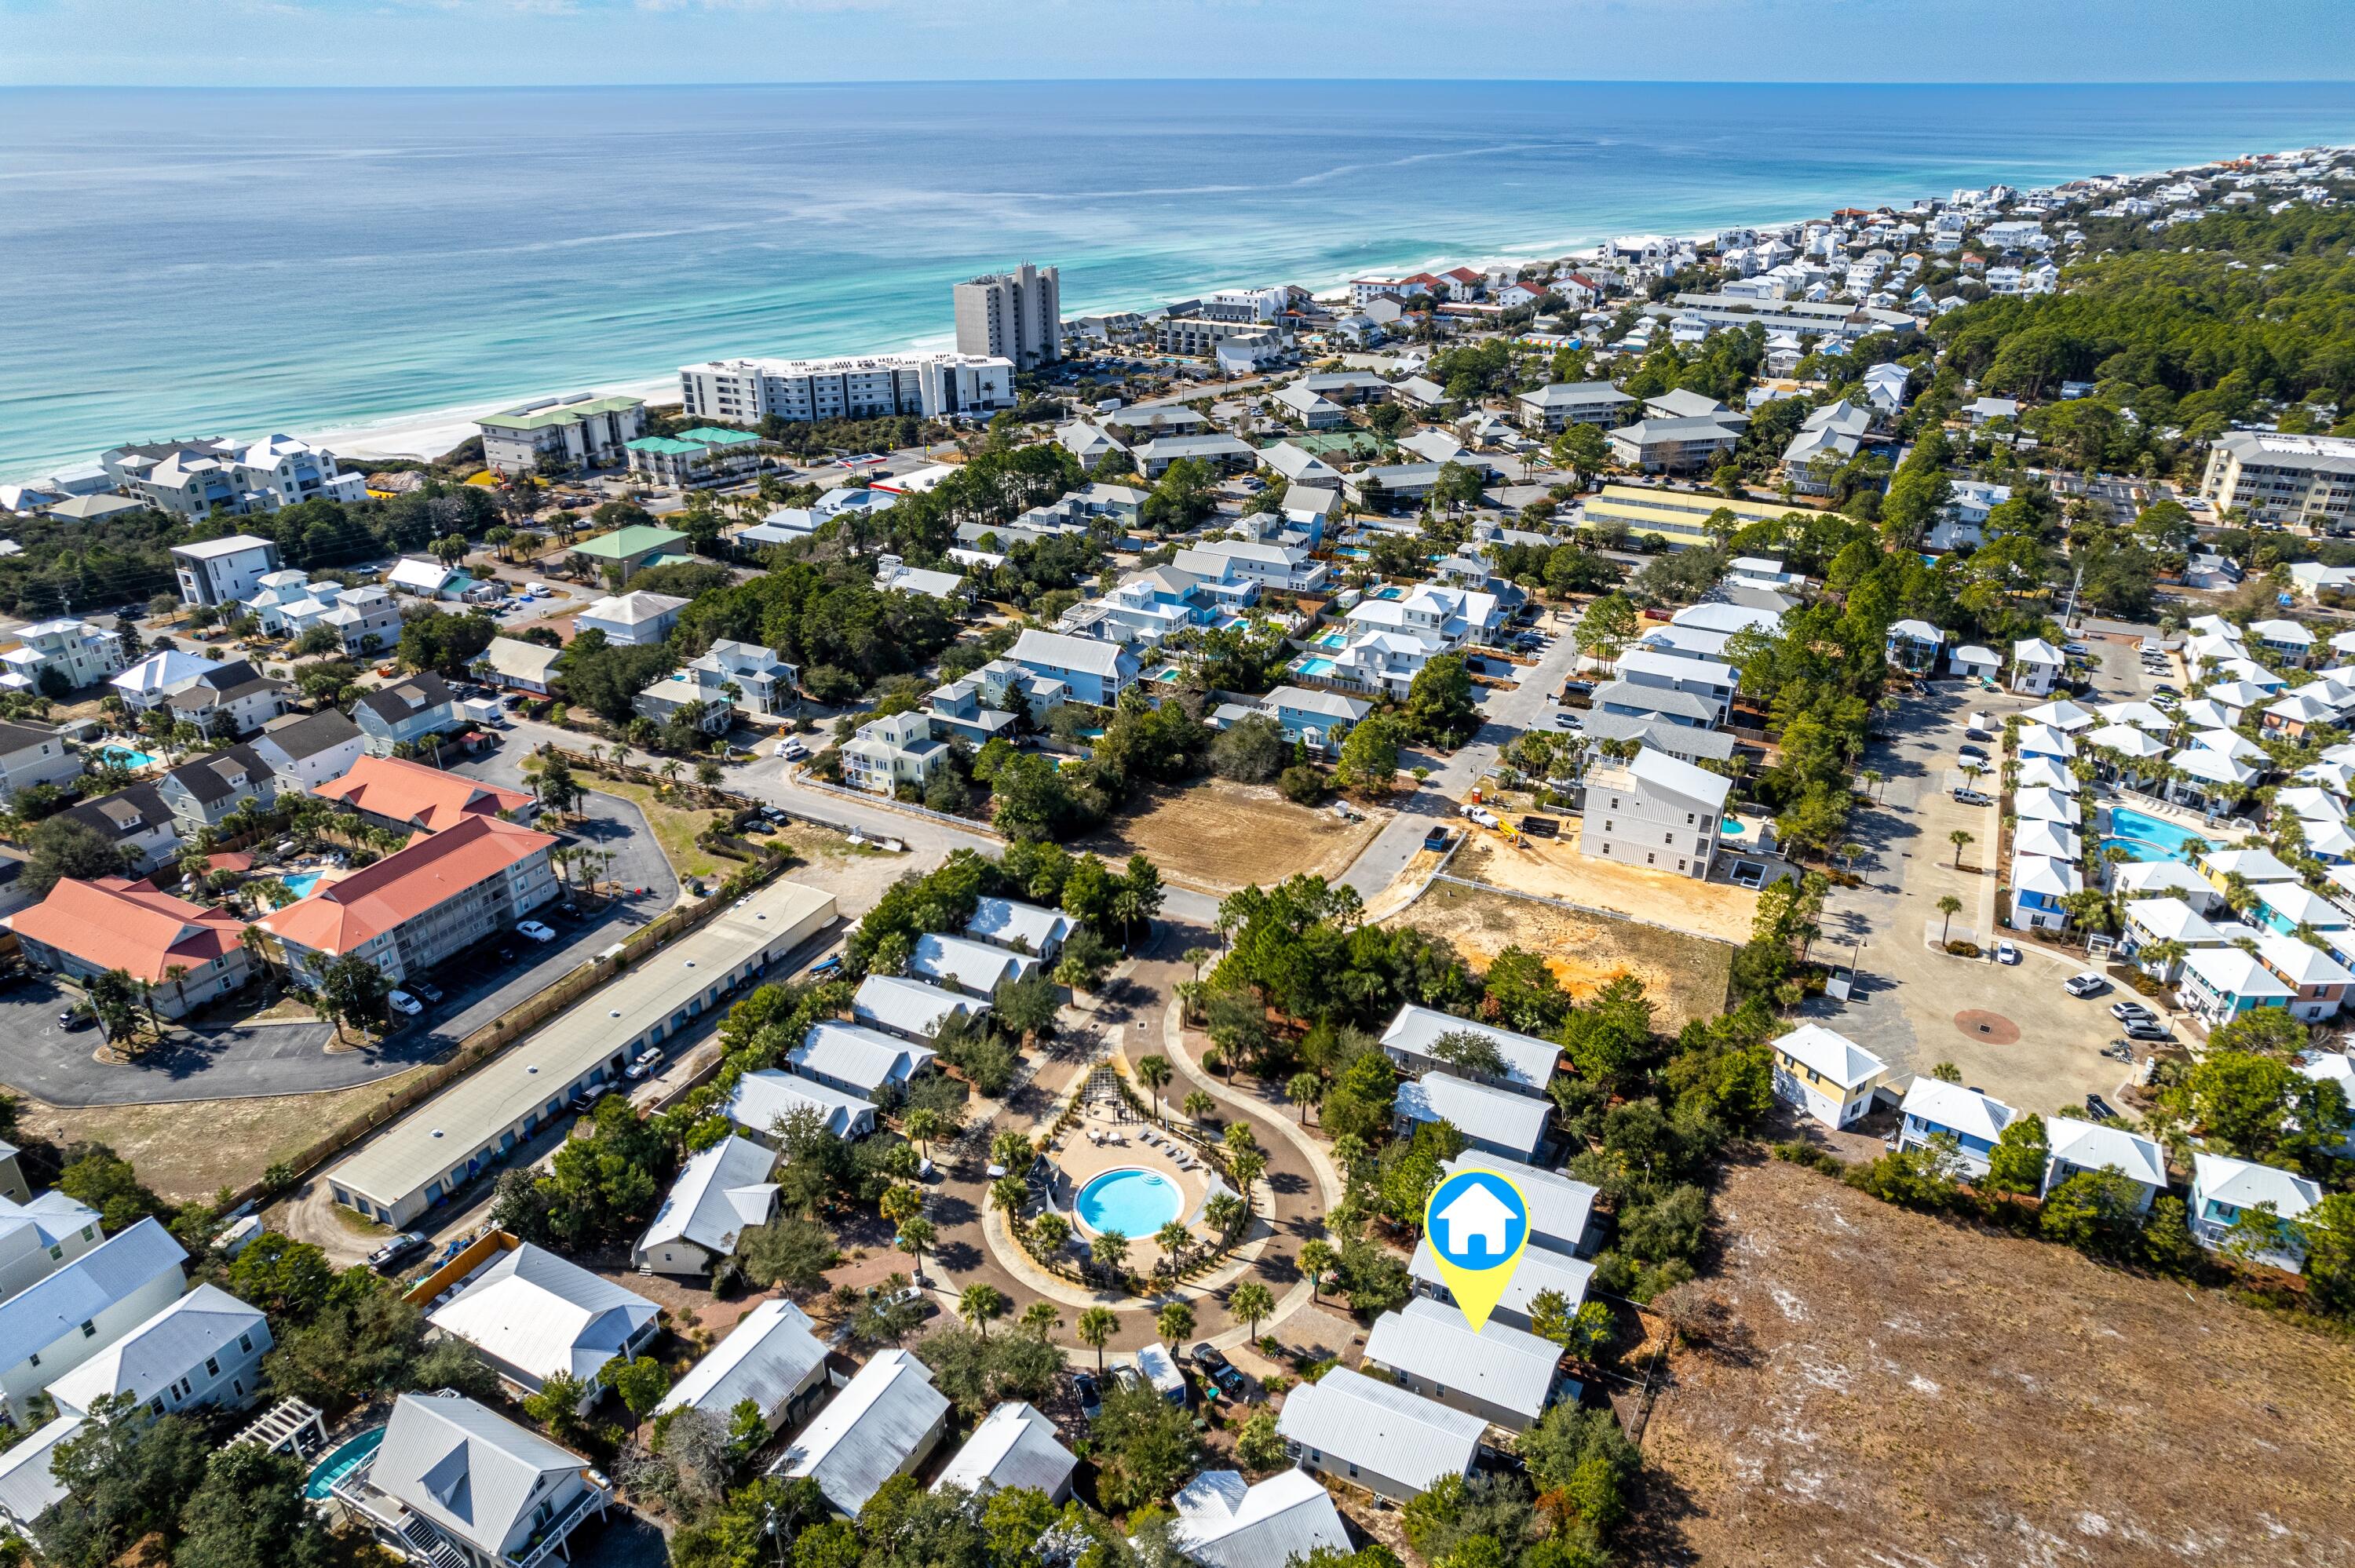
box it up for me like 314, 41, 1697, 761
1276, 1366, 1488, 1502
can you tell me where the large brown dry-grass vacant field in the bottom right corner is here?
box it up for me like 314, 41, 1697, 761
1644, 1161, 2355, 1568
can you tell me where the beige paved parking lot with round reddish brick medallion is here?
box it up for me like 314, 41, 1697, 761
1806, 636, 2157, 1114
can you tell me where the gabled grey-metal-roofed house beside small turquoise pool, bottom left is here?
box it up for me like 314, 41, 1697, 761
332, 1389, 610, 1568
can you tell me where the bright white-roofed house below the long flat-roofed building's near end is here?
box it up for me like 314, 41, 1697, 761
426, 1236, 662, 1408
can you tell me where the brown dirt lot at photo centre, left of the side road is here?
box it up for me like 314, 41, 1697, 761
1072, 779, 1392, 892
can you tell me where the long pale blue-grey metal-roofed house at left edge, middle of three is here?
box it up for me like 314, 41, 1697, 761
0, 1217, 188, 1427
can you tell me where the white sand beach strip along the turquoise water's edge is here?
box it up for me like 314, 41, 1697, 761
12, 144, 2336, 483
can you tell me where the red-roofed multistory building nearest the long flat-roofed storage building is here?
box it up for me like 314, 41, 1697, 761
259, 812, 558, 984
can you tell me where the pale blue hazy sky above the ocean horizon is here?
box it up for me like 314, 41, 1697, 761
13, 0, 2355, 87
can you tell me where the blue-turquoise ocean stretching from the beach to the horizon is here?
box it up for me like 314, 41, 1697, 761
0, 79, 2355, 478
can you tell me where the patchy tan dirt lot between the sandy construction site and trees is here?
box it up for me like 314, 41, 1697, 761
1385, 866, 1733, 1034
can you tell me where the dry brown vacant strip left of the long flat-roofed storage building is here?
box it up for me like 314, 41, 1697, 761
21, 1067, 426, 1198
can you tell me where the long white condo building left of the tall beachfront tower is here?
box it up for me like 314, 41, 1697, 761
678, 353, 1015, 424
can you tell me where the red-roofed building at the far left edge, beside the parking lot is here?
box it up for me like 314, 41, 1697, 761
7, 876, 252, 1017
